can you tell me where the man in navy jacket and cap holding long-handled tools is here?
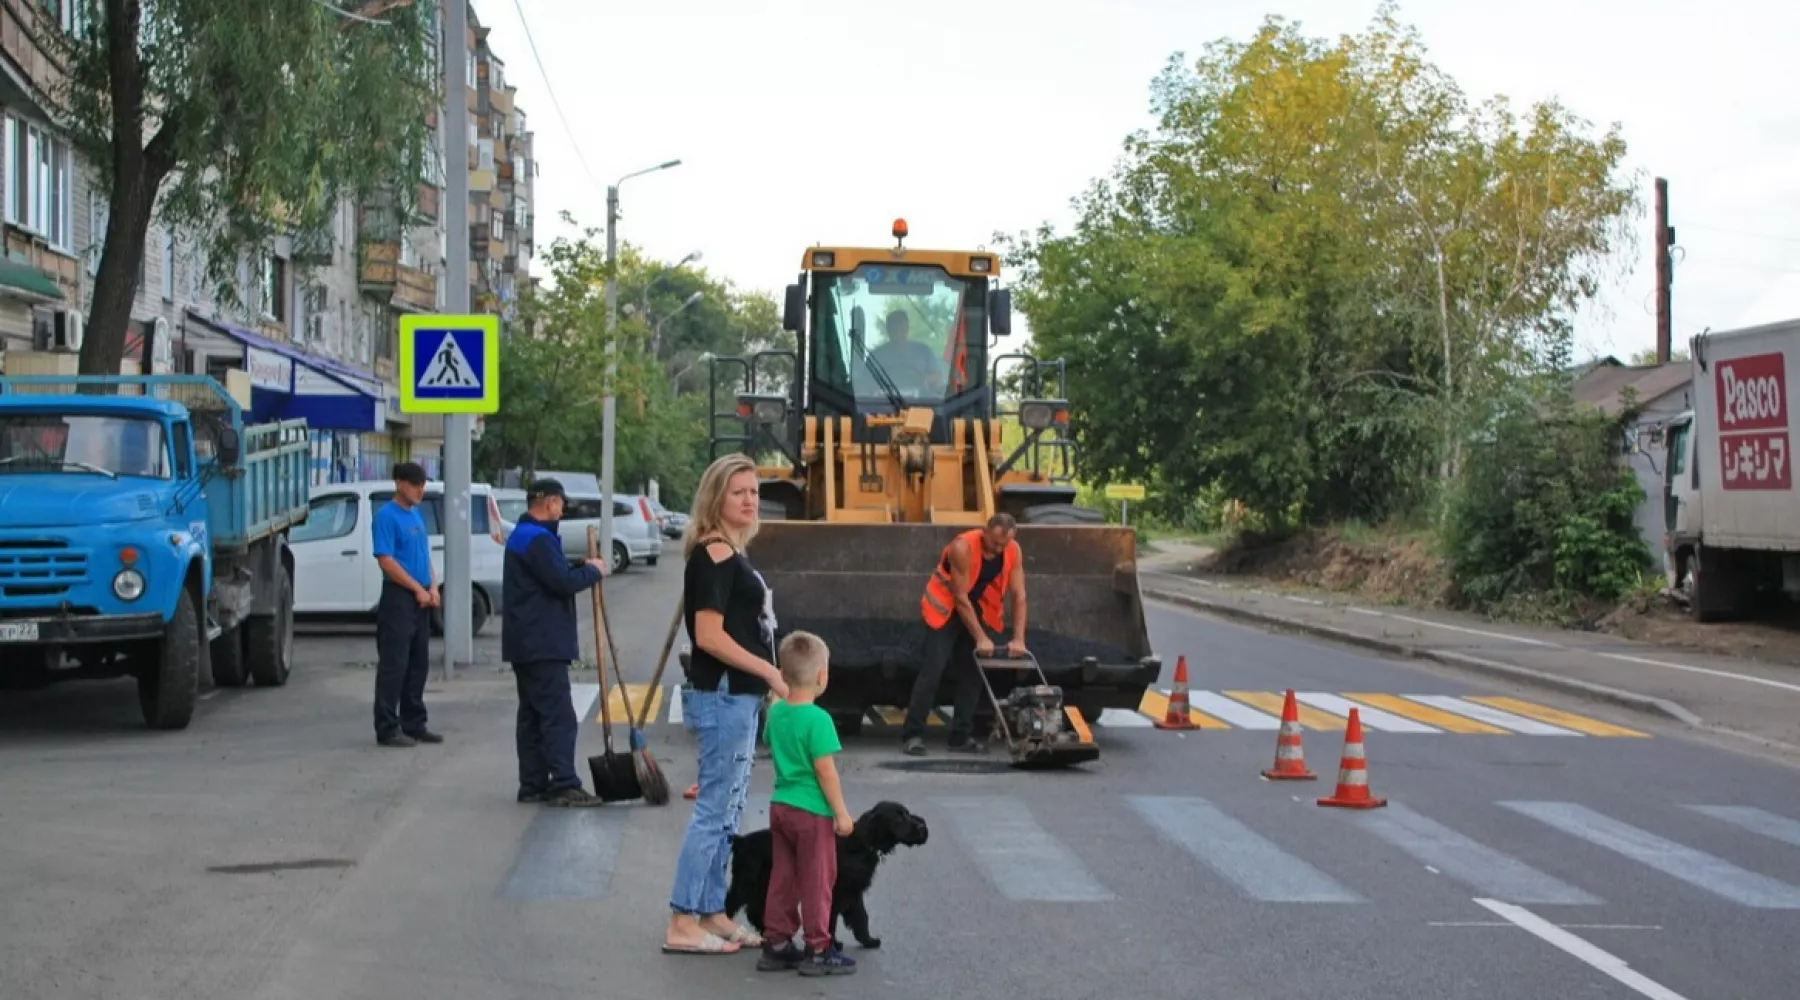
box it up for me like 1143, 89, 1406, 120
500, 478, 605, 806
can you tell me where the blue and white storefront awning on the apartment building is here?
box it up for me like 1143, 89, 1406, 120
187, 309, 387, 432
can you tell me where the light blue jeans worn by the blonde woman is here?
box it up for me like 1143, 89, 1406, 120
670, 680, 763, 915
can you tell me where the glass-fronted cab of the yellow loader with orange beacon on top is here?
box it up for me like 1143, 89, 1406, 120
783, 221, 1012, 437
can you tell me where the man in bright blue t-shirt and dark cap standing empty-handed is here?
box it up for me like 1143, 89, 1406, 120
373, 462, 445, 746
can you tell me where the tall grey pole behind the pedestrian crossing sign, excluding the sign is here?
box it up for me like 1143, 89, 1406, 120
441, 0, 475, 678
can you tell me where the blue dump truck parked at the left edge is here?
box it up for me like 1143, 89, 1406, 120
0, 374, 311, 728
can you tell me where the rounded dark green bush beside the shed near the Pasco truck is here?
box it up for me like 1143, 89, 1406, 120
1444, 399, 1651, 610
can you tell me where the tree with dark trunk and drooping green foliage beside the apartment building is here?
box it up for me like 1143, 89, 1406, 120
47, 0, 441, 374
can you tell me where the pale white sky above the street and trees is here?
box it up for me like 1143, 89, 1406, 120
475, 0, 1800, 360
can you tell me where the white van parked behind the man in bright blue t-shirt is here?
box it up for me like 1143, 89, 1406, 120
288, 480, 506, 635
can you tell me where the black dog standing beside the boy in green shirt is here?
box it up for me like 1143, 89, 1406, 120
725, 802, 931, 950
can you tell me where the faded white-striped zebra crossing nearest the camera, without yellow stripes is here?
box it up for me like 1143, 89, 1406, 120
506, 791, 1800, 912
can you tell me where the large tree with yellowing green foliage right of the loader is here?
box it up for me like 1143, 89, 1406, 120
1001, 5, 1636, 525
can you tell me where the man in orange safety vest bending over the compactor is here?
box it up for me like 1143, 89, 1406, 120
900, 514, 1026, 757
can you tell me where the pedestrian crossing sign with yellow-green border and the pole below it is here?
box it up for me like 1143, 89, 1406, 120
400, 315, 500, 678
